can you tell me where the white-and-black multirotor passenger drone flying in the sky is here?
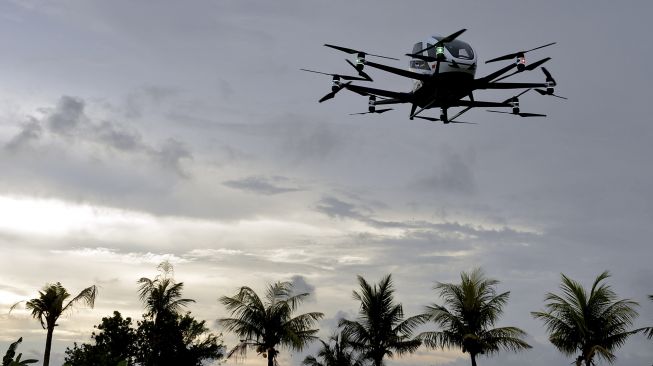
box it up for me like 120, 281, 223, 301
301, 29, 567, 124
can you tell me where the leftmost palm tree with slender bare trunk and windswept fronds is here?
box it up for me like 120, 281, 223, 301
9, 282, 97, 366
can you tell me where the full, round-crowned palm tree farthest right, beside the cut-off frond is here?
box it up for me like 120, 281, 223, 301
531, 271, 638, 366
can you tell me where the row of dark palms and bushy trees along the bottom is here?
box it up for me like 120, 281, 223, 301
2, 262, 653, 366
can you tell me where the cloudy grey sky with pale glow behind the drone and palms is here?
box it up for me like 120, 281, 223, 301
0, 0, 653, 366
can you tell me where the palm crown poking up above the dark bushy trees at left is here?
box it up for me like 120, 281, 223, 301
138, 261, 195, 324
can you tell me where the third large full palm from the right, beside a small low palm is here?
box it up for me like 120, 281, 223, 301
339, 274, 423, 366
